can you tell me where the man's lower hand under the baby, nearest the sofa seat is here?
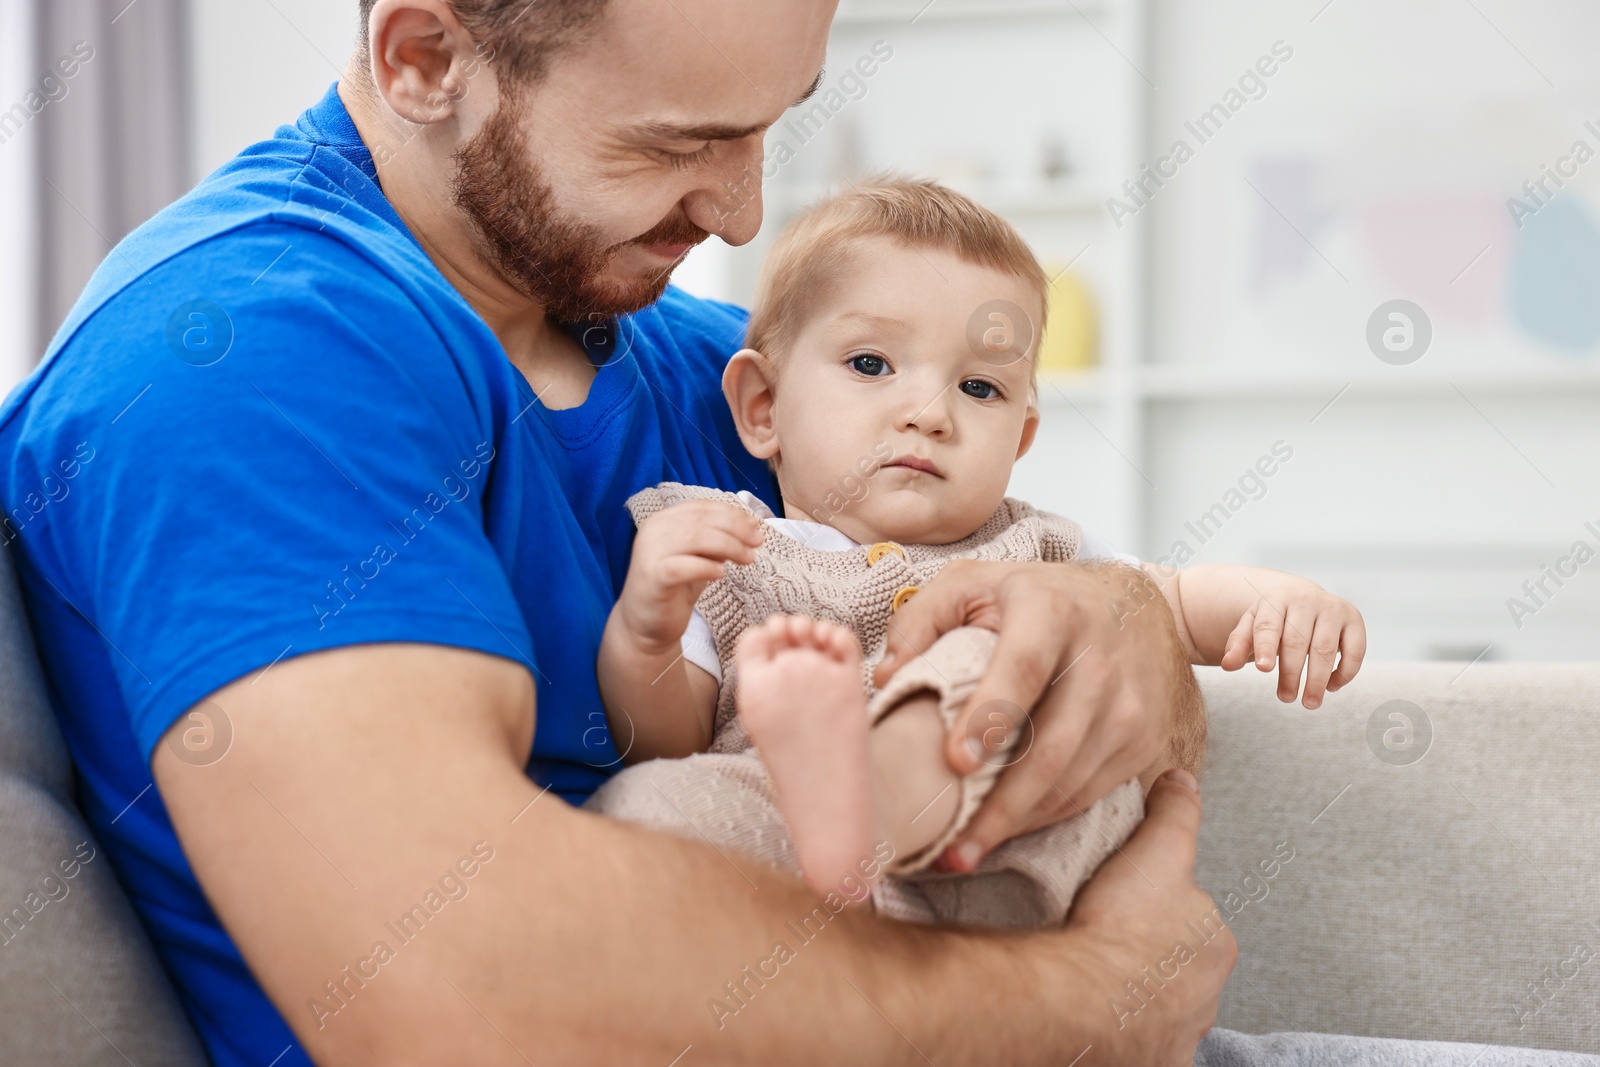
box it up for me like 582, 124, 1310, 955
1067, 771, 1238, 1067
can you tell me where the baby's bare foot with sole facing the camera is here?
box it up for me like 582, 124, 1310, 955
734, 616, 874, 894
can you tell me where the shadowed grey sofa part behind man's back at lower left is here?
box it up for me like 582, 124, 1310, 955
0, 550, 206, 1067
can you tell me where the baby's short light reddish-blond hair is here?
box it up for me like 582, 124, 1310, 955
746, 178, 1050, 367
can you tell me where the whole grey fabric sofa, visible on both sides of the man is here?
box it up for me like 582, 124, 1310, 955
0, 518, 1600, 1067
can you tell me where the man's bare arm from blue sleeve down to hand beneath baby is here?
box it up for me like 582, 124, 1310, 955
154, 645, 1232, 1067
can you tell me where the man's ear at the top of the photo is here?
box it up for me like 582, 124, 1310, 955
366, 0, 480, 125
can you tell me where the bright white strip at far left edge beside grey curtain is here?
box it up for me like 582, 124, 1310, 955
0, 2, 45, 394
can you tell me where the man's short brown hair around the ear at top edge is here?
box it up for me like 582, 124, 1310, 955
360, 0, 606, 85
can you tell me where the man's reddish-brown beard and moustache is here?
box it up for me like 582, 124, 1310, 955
454, 104, 709, 323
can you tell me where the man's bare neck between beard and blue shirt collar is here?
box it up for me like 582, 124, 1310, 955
339, 72, 595, 408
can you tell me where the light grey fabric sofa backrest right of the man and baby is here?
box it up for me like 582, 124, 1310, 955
1198, 664, 1600, 1053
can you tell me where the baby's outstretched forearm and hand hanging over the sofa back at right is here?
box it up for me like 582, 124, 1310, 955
1146, 563, 1366, 707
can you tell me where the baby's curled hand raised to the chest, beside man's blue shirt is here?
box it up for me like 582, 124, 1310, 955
616, 501, 762, 653
